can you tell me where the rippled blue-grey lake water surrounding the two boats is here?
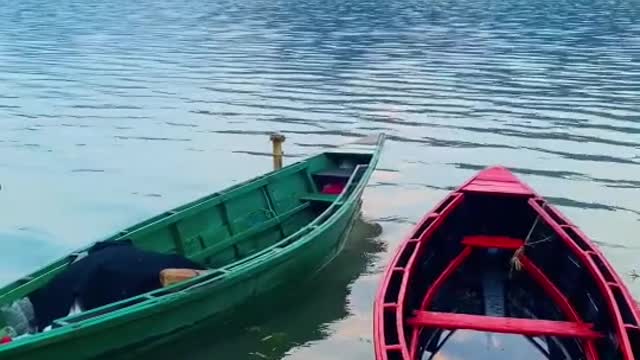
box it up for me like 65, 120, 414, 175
0, 0, 640, 360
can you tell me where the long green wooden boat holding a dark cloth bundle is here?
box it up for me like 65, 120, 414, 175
0, 135, 384, 360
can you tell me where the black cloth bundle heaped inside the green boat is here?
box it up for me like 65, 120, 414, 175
29, 241, 203, 331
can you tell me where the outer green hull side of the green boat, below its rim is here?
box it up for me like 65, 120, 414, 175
0, 204, 359, 360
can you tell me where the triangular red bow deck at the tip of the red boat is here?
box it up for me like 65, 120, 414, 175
461, 166, 535, 196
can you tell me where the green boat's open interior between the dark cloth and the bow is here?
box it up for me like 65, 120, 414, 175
120, 153, 371, 268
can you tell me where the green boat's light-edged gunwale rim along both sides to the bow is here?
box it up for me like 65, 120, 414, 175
0, 134, 385, 355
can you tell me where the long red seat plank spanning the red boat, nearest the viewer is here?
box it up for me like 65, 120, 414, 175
408, 311, 602, 339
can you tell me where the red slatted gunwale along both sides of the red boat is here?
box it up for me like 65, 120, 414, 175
373, 167, 640, 360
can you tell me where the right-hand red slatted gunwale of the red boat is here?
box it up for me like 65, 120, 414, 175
529, 198, 637, 360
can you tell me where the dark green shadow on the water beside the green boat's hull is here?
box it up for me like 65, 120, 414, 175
109, 217, 384, 360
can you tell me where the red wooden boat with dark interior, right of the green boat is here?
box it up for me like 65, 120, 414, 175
374, 167, 640, 360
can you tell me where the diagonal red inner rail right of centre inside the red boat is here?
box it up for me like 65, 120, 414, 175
519, 255, 599, 360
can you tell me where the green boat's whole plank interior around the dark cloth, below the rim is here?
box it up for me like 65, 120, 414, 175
0, 152, 373, 328
